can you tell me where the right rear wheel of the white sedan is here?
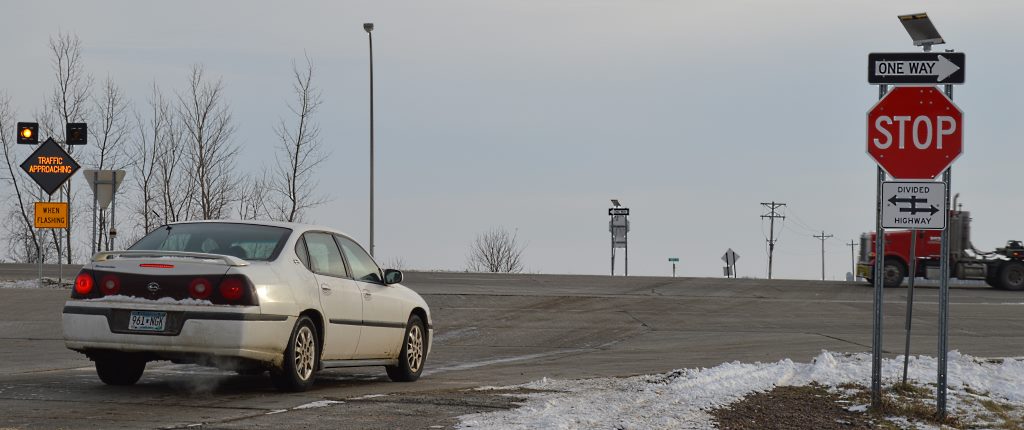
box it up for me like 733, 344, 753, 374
270, 316, 319, 392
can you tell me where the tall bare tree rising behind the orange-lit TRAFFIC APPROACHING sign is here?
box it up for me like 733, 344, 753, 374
40, 33, 92, 264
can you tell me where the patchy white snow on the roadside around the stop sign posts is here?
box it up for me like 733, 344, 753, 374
459, 351, 1024, 429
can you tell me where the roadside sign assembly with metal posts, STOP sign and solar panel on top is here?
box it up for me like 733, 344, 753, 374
866, 13, 966, 419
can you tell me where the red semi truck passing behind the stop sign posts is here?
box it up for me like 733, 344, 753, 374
857, 196, 1024, 291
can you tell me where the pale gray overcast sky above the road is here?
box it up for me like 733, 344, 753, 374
0, 0, 1024, 278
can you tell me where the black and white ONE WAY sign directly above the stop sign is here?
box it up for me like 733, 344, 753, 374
867, 52, 966, 85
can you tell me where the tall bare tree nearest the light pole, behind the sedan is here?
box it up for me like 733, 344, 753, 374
267, 56, 328, 221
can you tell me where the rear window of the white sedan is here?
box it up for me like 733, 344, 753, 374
129, 222, 292, 261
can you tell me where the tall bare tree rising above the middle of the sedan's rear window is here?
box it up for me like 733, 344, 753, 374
178, 65, 239, 219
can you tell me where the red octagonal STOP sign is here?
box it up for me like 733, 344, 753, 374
867, 87, 964, 179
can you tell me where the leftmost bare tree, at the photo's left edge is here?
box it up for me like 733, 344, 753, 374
0, 92, 43, 263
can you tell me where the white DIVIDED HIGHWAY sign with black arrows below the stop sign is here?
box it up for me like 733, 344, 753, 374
882, 182, 947, 230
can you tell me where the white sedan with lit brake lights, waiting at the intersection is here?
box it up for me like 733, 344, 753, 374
63, 221, 433, 391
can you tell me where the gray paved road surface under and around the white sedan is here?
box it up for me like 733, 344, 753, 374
0, 270, 1024, 429
